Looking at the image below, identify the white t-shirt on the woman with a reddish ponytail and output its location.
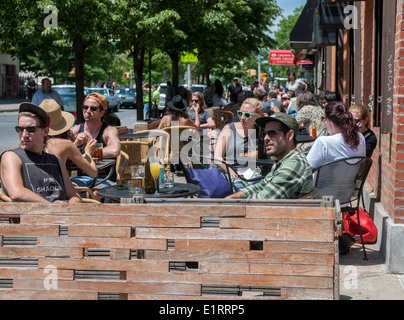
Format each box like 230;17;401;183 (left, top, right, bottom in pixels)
307;133;366;168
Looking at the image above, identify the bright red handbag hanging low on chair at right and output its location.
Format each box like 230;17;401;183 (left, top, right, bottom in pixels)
343;208;377;243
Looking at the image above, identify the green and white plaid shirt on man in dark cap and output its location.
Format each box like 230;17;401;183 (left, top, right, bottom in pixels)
240;149;313;199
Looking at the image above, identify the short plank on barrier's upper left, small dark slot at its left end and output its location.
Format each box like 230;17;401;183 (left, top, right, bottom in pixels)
69;225;131;238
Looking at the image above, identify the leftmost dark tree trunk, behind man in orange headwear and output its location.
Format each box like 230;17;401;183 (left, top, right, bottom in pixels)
73;34;86;123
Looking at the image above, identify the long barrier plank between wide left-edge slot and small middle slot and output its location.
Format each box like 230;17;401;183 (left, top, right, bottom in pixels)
38;237;167;250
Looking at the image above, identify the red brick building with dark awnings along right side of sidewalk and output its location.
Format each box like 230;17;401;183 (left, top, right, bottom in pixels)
290;0;404;273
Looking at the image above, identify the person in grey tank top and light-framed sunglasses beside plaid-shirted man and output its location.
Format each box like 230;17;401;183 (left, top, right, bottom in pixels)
215;98;263;192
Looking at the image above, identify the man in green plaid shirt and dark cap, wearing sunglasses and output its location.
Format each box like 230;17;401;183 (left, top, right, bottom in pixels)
227;112;313;199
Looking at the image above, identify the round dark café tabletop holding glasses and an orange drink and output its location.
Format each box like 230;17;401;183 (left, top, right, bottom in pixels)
98;182;200;201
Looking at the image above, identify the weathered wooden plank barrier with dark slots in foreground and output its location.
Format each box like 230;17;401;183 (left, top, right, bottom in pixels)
0;199;339;300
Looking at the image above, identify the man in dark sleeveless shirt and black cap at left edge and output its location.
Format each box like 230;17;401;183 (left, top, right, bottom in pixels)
1;103;81;203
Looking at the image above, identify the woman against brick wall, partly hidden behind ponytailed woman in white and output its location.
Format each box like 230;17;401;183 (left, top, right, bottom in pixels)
349;104;377;157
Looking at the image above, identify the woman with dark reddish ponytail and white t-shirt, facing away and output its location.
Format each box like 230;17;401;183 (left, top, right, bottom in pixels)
307;101;366;169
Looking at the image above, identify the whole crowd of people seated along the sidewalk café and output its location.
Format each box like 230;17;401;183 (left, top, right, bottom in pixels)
0;71;377;202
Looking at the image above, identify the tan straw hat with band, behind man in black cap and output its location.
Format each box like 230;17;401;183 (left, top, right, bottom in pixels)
39;99;75;136
